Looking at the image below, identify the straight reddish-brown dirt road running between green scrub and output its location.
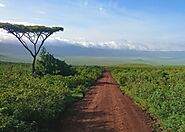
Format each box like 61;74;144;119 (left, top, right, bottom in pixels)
57;72;152;132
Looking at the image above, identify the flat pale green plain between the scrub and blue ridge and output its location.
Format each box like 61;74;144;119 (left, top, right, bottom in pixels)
0;56;185;66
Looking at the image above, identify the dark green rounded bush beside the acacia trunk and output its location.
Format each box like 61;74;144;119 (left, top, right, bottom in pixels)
36;48;74;76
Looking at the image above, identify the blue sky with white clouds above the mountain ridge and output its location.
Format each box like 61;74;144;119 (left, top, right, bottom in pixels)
0;0;185;51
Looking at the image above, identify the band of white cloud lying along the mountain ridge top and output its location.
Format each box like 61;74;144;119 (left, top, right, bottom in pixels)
0;30;185;51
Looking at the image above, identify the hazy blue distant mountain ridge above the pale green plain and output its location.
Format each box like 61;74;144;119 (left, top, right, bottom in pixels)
0;42;185;59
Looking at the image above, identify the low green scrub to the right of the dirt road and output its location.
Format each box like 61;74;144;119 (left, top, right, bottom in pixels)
110;65;185;132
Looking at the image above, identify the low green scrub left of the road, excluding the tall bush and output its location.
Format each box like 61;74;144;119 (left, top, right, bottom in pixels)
0;63;102;132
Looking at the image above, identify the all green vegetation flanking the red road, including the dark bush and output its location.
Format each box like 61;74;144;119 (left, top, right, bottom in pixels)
0;50;185;132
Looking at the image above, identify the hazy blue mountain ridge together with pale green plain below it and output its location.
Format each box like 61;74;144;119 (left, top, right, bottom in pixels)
0;42;185;65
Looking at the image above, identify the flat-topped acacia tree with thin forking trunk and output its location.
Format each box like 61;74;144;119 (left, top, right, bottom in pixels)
0;23;64;75
